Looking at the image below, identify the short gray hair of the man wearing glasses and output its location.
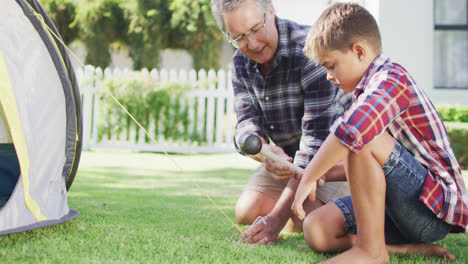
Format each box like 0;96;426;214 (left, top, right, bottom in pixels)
211;0;271;33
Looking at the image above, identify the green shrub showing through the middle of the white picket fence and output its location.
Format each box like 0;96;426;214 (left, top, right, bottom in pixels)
98;77;190;143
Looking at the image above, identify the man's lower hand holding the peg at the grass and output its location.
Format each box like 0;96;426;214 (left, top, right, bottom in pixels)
241;215;282;245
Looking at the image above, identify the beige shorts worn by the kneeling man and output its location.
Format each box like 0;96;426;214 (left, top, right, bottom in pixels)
244;164;350;203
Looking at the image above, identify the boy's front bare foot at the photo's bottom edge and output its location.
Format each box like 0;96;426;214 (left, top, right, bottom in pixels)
322;247;390;264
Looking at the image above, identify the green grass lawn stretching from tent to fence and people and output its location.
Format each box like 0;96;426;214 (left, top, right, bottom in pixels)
0;151;468;263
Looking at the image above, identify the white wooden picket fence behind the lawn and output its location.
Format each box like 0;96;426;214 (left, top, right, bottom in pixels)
76;66;236;153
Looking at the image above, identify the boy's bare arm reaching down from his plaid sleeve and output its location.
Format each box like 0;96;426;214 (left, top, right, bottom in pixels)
291;134;349;220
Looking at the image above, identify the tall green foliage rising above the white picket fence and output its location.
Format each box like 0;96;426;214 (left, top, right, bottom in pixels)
41;0;224;70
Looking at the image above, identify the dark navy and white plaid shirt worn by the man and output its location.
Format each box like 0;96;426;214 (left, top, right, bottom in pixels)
232;17;351;167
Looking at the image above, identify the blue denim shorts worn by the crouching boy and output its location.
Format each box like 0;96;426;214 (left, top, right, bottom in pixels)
332;141;452;244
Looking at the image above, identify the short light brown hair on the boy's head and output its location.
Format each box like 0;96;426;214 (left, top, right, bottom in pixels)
304;3;382;60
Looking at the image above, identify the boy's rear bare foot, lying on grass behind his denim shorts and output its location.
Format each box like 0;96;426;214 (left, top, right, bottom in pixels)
387;244;456;260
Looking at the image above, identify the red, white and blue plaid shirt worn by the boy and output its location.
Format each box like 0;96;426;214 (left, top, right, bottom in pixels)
330;54;468;233
